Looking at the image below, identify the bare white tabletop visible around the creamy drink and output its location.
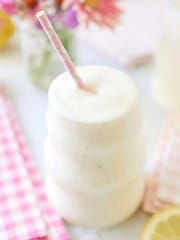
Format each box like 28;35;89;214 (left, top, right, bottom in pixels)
0;38;165;240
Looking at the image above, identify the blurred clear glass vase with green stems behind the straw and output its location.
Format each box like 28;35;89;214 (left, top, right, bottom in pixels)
20;21;74;90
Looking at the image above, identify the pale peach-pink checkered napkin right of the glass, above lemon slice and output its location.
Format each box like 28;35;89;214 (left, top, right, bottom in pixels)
143;118;180;213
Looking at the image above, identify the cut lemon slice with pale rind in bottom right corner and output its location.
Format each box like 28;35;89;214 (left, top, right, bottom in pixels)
141;207;180;240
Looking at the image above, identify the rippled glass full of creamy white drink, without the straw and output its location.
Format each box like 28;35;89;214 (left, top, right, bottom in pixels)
45;66;144;227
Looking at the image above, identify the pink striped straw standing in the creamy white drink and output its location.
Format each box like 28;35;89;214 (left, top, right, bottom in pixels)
36;11;86;90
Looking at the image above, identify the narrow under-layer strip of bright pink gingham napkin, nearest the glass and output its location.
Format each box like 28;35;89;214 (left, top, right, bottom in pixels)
14;115;69;240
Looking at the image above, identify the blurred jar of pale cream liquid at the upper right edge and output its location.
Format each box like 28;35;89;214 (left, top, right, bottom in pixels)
153;0;180;113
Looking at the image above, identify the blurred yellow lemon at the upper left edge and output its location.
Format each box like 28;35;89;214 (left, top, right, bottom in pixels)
0;10;14;48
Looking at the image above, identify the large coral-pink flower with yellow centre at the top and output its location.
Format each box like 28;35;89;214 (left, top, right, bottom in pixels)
65;0;123;29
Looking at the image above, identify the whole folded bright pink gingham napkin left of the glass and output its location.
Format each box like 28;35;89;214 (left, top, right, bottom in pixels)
0;86;69;240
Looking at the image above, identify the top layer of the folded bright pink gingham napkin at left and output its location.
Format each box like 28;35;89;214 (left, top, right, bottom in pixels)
0;92;46;240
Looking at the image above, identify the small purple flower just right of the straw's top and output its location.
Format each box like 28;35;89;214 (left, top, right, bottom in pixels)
61;7;79;28
